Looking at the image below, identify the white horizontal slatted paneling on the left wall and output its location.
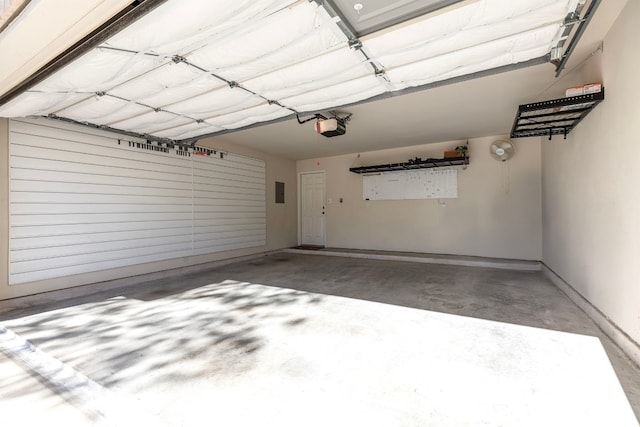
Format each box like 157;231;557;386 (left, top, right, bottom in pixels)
9;120;266;285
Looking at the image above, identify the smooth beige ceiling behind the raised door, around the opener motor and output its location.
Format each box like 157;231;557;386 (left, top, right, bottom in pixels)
208;64;554;160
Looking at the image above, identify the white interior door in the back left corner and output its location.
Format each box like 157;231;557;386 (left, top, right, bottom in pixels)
300;172;325;246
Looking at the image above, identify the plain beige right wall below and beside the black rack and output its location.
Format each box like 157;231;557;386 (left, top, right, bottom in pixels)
543;1;640;343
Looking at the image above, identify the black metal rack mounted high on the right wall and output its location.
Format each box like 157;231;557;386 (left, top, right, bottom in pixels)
511;88;604;139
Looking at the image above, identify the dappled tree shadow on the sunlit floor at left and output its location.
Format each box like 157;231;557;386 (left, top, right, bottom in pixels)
2;276;323;418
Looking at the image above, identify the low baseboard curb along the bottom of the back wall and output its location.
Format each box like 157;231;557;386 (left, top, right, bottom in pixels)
284;248;540;271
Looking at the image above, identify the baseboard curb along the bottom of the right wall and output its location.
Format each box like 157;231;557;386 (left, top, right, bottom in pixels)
542;263;640;366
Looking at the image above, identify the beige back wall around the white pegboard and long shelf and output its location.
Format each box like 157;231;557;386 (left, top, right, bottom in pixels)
298;136;541;260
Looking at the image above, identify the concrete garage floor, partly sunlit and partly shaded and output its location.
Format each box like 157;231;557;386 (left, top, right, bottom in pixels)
0;253;640;426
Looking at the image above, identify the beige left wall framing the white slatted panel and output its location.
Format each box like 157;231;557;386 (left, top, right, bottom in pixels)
0;125;297;300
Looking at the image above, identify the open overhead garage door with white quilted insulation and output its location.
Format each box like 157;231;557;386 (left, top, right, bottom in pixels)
0;0;597;143
